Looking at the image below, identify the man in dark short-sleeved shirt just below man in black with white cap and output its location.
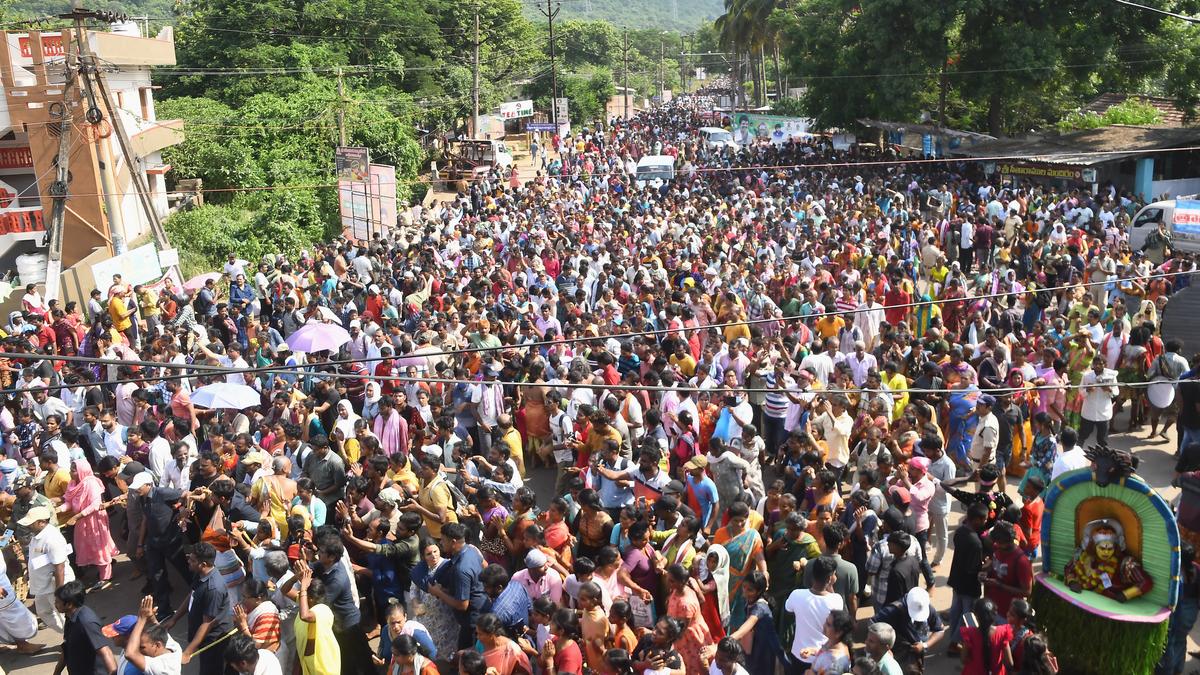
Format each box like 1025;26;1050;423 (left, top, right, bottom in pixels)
163;542;233;675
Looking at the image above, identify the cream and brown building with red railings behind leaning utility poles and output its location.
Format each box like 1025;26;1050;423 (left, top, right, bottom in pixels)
0;23;184;276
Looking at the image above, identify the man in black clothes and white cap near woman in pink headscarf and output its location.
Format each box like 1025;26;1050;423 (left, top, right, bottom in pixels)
130;471;192;621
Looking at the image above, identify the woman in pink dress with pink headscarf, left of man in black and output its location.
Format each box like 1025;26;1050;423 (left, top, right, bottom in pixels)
58;459;118;591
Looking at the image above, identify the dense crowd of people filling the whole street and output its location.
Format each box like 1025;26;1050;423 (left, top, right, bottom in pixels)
0;96;1200;675
